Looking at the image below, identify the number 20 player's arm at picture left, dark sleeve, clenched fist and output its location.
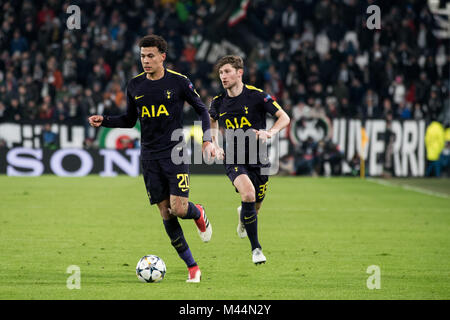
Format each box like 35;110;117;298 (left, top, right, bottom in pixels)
88;90;138;128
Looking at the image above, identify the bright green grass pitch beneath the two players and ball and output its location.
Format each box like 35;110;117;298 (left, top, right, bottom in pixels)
0;175;450;300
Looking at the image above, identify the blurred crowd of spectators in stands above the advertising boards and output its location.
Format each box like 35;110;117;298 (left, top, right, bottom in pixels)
0;0;450;176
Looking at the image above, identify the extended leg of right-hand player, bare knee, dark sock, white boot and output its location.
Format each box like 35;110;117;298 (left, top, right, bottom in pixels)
233;174;266;265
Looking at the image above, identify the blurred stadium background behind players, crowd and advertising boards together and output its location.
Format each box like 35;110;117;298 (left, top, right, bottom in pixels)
0;0;450;177
